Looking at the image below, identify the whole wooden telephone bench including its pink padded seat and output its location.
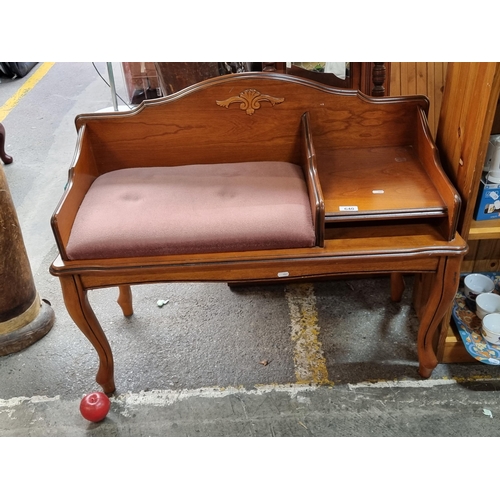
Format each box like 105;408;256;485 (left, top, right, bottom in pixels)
50;72;467;394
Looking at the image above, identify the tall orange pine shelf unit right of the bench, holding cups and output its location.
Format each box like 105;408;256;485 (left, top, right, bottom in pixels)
415;62;500;363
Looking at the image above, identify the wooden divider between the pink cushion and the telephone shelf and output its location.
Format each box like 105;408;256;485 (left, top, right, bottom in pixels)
302;112;325;247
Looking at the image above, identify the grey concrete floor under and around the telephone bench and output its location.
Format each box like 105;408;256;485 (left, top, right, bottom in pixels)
0;63;500;437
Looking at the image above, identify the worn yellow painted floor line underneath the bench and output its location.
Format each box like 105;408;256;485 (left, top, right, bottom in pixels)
285;283;331;385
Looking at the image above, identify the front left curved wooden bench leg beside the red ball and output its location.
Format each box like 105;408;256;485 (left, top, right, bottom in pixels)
59;275;115;395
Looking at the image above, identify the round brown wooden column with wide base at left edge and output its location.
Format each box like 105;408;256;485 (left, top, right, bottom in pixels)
0;164;55;356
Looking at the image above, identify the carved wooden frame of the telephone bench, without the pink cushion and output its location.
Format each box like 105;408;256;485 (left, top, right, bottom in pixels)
50;73;467;394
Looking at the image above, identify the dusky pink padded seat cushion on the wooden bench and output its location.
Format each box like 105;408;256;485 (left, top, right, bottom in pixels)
67;162;315;260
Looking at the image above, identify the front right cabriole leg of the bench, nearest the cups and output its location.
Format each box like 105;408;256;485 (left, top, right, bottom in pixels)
417;256;462;378
